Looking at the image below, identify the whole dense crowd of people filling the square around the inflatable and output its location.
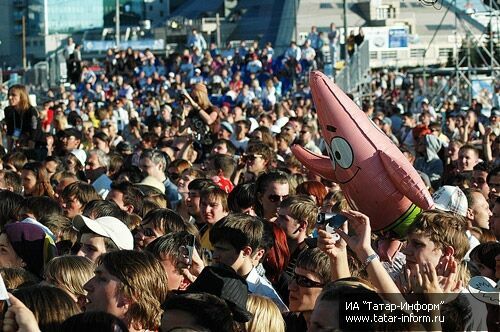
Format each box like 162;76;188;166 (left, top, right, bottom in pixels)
0;25;500;332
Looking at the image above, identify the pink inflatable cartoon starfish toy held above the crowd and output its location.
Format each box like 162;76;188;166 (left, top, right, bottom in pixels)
292;71;434;239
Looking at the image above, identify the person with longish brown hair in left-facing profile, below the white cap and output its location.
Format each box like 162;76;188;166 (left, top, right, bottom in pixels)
84;250;168;331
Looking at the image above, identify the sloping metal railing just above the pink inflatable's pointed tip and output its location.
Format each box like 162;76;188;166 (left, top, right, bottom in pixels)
335;40;370;92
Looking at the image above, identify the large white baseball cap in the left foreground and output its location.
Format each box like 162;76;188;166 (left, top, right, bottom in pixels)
73;215;134;250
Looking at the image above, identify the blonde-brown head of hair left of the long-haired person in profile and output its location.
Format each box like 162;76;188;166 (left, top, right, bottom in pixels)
44;256;95;310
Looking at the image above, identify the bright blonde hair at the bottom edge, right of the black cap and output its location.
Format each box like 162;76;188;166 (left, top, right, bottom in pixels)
245;295;285;332
